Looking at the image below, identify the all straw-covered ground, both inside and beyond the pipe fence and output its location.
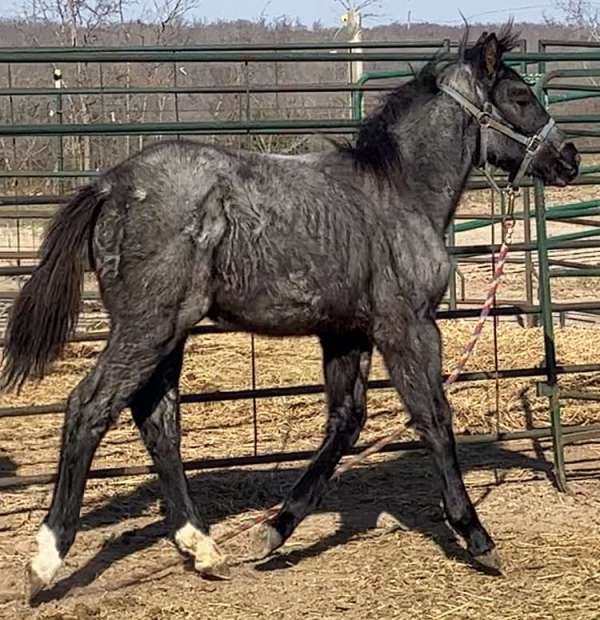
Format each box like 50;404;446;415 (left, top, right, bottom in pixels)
0;323;600;620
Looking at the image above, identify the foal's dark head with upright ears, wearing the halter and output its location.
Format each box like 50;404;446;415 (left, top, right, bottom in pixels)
438;28;580;186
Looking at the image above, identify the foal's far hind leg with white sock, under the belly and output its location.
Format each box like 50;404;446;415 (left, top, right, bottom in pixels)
131;342;229;578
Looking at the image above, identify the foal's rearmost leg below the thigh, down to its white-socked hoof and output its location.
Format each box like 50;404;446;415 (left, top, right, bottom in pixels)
29;325;176;598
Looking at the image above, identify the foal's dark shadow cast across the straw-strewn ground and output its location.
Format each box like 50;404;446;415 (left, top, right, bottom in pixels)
36;444;552;604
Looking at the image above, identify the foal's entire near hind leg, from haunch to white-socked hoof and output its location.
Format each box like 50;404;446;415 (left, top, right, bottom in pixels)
25;180;226;595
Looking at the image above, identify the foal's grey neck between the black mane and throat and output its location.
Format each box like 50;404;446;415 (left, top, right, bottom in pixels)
396;97;477;235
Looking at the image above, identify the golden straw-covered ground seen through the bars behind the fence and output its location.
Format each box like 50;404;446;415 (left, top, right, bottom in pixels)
0;321;600;474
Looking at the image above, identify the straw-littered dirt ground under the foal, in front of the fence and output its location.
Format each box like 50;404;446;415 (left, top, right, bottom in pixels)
0;443;600;620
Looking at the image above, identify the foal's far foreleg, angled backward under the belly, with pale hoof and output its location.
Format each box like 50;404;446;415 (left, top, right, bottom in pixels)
255;333;372;558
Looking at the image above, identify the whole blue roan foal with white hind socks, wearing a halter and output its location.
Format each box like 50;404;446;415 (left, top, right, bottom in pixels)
2;28;579;597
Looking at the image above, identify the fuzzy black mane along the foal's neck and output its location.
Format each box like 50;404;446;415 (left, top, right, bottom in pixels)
339;56;443;178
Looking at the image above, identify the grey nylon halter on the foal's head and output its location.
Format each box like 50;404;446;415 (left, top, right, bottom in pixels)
439;84;556;189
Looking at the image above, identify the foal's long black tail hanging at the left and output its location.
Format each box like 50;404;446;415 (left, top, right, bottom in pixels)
0;184;105;389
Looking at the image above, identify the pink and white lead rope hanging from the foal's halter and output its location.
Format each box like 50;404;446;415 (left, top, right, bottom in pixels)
216;213;515;543
